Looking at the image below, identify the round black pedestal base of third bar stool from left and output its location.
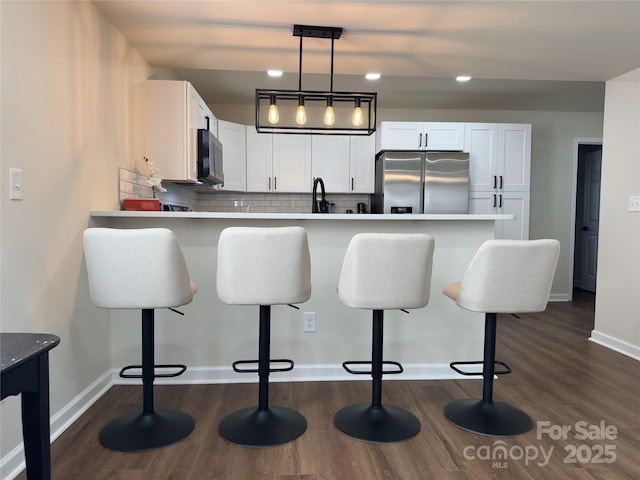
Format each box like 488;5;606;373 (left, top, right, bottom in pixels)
333;403;420;443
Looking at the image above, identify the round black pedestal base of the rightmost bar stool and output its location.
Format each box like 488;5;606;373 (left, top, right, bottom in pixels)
444;398;533;437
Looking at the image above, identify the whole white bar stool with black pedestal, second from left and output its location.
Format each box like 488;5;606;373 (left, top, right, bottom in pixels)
216;227;311;447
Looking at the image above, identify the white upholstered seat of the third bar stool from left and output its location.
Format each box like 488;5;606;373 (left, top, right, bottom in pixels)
338;233;434;310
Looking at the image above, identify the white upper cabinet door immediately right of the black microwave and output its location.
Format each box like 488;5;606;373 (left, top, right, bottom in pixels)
218;120;247;192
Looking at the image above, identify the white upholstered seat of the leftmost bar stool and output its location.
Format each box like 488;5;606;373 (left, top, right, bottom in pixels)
84;228;198;309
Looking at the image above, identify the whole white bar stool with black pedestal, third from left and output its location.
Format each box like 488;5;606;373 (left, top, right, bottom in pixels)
334;233;434;442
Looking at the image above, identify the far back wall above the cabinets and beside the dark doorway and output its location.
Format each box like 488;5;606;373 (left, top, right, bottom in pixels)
215;105;603;299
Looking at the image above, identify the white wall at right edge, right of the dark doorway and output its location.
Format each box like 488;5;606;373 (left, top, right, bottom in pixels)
591;69;640;359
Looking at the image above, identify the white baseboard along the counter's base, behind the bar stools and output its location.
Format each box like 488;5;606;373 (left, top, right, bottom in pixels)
112;363;469;385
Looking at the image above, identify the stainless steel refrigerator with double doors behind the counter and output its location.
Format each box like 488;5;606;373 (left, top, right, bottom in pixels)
371;151;469;214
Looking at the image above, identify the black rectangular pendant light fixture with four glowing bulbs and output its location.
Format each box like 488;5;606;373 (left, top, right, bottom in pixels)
256;25;377;135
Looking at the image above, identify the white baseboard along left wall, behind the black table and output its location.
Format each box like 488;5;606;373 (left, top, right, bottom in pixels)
0;370;113;480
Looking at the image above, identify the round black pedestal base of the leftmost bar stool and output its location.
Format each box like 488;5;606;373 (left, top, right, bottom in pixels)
99;410;195;452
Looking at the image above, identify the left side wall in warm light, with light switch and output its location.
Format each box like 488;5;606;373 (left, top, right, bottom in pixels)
0;2;148;478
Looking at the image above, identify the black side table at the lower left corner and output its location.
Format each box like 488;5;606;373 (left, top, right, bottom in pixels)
0;333;60;480
